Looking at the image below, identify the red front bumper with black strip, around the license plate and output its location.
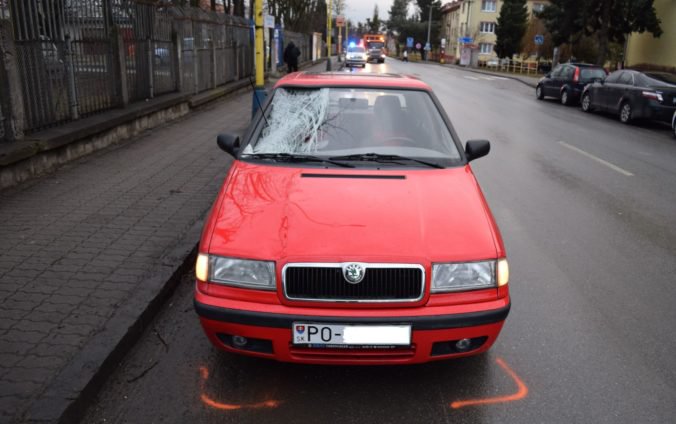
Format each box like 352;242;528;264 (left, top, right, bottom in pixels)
195;296;510;365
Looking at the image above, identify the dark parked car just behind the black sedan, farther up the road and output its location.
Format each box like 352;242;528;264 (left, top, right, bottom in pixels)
535;63;606;106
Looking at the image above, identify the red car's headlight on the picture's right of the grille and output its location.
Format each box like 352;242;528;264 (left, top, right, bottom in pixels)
431;259;509;293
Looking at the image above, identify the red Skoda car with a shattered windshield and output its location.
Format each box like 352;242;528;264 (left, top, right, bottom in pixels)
195;73;510;364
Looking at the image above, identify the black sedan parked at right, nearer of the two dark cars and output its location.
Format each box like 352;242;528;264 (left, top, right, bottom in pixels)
581;69;676;124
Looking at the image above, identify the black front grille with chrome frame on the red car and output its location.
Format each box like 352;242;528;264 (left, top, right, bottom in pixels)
284;264;425;302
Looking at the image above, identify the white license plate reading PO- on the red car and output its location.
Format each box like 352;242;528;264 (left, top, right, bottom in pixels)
291;322;411;347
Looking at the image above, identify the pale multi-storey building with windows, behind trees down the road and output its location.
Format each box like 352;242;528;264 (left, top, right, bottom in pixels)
441;0;548;62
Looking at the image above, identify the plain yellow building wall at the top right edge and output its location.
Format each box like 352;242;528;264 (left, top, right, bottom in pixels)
625;0;676;72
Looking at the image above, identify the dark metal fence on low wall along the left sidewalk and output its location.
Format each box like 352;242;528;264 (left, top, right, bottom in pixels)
0;0;253;135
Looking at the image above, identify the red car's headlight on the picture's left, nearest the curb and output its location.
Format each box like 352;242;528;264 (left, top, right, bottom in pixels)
195;253;276;290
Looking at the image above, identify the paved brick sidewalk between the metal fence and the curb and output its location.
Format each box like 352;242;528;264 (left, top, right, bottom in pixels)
0;57;336;423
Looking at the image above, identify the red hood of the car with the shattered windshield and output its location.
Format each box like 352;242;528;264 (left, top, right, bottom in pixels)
207;161;504;263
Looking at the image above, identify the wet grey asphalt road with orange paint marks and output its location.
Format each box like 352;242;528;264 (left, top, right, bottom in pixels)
83;61;676;423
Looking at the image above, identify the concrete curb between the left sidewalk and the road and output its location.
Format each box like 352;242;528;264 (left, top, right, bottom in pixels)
22;220;206;423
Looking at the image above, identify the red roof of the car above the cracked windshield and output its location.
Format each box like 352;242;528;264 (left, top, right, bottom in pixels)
275;72;432;91
